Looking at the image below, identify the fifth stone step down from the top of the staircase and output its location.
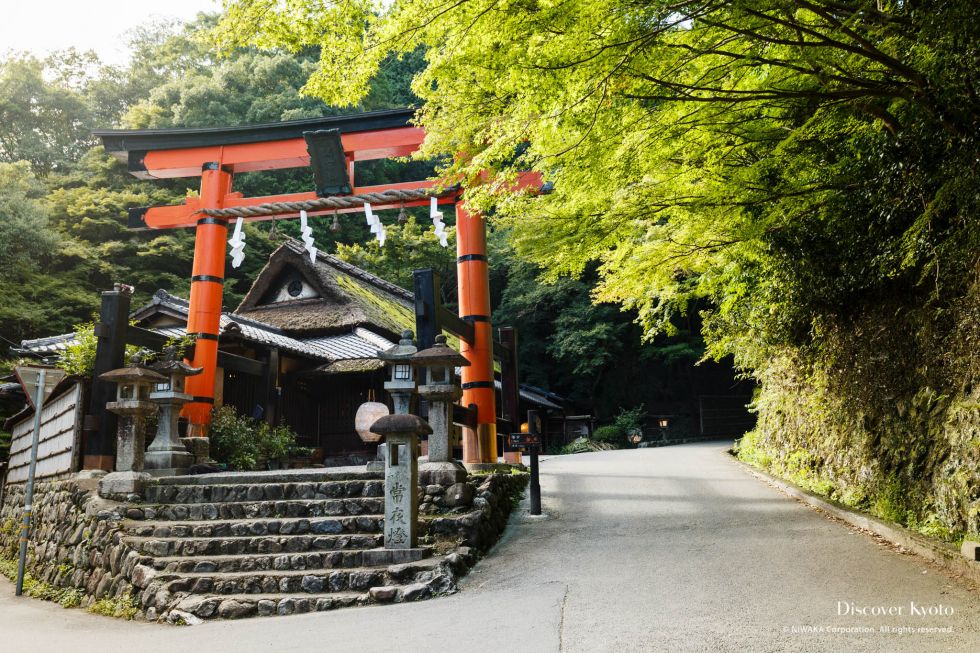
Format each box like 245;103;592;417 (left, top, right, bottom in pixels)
125;533;384;557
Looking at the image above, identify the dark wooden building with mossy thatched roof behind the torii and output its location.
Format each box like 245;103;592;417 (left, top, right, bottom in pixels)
22;240;415;465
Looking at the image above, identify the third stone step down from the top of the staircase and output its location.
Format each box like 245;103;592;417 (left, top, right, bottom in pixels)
126;497;384;521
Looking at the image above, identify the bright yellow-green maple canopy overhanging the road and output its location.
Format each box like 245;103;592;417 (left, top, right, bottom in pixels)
220;0;980;364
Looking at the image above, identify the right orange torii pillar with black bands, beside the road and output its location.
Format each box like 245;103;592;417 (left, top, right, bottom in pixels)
456;202;497;464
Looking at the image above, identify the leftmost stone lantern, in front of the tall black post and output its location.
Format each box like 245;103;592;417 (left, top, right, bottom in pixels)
99;357;166;496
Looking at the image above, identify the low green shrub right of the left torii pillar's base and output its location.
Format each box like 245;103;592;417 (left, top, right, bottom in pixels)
210;406;296;470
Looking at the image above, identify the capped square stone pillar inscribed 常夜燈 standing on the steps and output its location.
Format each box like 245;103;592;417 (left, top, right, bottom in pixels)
371;415;432;549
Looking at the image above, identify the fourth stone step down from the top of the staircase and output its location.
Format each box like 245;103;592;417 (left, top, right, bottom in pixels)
123;515;384;537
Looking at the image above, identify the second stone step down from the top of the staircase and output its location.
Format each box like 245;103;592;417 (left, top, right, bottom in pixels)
146;479;384;504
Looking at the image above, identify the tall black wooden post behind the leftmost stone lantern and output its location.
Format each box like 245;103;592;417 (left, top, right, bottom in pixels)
82;283;133;471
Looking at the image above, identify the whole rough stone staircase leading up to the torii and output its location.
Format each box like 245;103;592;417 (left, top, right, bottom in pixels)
121;468;455;621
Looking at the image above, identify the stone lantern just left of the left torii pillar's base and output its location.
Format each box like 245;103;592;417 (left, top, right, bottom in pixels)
146;348;203;476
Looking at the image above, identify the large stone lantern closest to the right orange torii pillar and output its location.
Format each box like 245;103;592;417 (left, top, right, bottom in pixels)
412;334;470;485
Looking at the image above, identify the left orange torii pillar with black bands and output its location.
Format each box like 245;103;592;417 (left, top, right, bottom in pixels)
182;161;232;436
